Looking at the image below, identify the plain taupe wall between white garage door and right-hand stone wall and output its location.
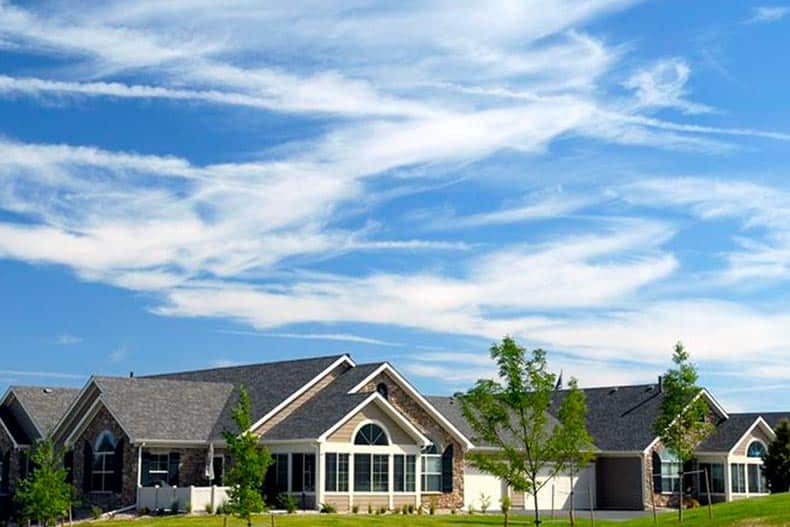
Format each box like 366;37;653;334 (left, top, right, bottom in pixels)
595;456;644;510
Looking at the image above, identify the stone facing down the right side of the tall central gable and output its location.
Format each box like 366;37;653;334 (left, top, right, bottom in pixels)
360;373;465;509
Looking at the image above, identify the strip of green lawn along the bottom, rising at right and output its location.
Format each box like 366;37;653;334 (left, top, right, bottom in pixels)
106;494;790;527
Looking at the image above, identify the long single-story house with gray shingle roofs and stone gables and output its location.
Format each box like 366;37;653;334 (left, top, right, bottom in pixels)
0;355;790;514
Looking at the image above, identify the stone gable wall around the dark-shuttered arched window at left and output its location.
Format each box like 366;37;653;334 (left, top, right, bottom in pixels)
73;406;137;509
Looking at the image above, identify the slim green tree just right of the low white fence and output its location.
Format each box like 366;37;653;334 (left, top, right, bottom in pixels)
224;386;272;527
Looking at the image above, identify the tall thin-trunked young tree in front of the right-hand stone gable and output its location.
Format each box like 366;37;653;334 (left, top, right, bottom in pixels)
655;342;713;521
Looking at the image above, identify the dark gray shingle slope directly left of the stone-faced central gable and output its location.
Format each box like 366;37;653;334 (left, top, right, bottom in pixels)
263;363;384;440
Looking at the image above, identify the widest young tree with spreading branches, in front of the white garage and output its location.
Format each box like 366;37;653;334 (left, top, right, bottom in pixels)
458;337;584;525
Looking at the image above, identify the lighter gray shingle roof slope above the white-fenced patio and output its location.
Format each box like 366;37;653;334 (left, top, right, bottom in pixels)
94;377;236;441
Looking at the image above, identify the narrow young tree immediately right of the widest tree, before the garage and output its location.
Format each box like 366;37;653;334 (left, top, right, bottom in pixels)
557;378;595;527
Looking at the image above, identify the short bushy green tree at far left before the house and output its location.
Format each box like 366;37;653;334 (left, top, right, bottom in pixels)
16;438;73;527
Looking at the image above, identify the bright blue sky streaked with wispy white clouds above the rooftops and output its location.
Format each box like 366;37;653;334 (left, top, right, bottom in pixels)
0;0;790;410
